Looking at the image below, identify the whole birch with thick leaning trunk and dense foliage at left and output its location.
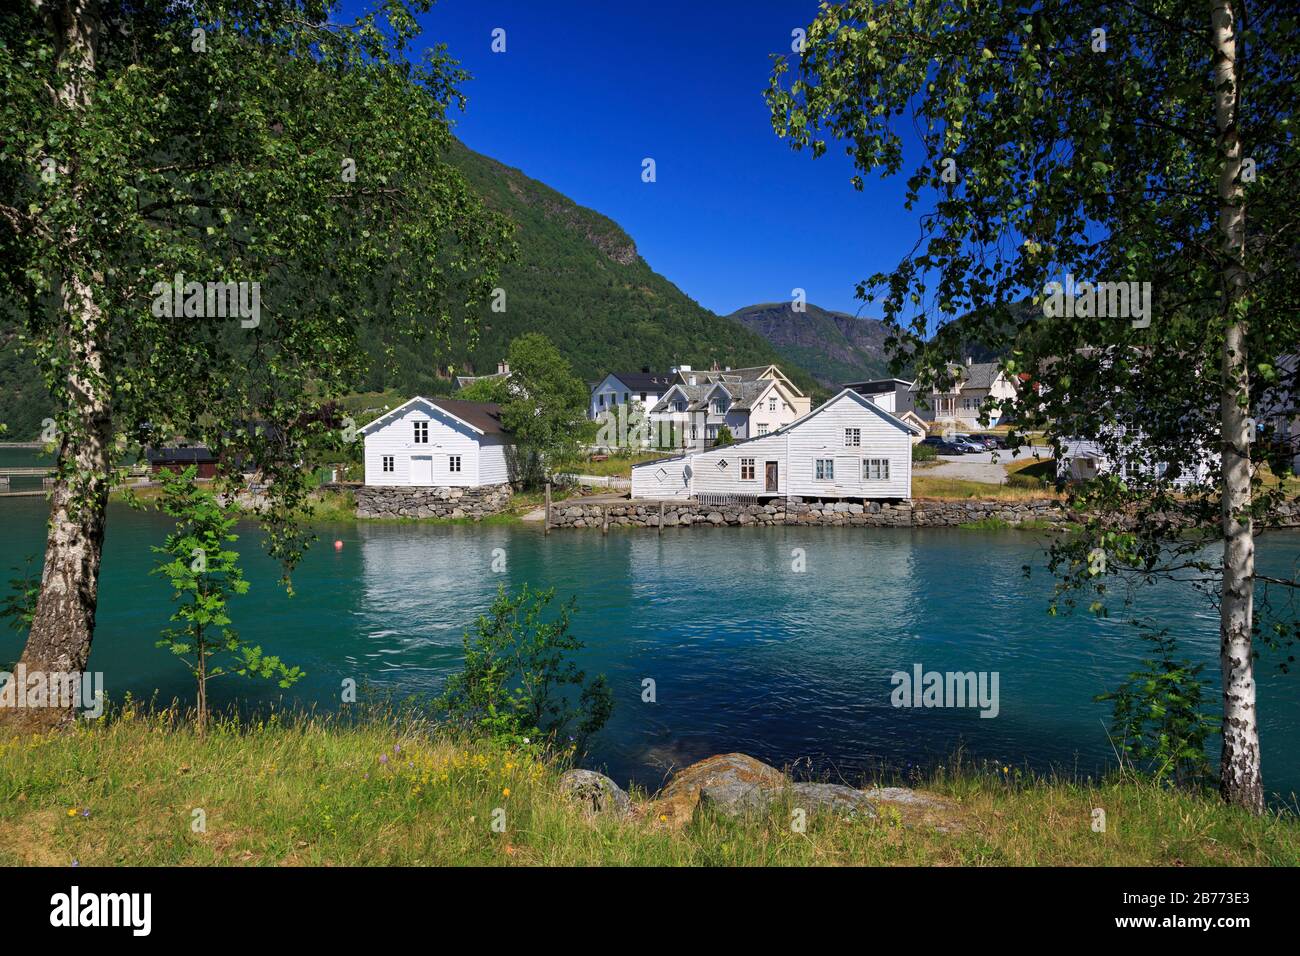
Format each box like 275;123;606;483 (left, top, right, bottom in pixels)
0;0;508;722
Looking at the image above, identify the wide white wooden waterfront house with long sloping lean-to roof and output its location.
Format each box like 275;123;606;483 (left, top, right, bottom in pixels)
632;389;917;499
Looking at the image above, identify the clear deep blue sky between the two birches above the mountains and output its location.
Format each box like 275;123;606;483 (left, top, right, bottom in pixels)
358;0;918;315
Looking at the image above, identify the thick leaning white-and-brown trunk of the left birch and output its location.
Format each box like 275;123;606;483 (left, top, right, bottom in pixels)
4;0;112;727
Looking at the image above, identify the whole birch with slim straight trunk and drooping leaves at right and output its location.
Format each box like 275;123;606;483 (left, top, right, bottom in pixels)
767;0;1300;812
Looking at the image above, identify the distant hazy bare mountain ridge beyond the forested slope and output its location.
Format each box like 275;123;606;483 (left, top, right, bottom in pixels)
727;302;889;392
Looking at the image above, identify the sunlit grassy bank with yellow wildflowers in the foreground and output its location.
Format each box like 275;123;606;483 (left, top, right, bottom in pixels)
0;705;1300;866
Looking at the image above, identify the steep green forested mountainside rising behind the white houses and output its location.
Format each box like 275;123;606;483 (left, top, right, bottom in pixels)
0;143;815;440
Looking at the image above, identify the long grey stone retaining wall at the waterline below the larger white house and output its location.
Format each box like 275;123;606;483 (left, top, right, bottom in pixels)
551;498;1300;528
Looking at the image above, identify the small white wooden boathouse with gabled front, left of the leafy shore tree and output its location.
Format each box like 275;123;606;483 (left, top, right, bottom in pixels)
361;397;511;488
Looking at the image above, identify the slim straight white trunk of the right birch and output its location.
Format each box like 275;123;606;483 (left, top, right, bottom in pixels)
1210;0;1264;813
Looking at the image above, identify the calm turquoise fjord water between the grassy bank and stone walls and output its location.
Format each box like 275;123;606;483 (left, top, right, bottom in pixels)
0;498;1300;795
